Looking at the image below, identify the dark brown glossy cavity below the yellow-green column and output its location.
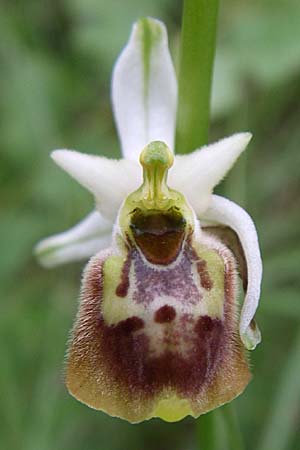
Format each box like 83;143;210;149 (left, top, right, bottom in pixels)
130;208;186;265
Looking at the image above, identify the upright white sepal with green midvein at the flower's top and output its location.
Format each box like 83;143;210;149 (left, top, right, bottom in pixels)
112;18;177;161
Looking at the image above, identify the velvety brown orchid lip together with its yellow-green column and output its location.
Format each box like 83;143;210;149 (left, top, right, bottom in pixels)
66;141;250;422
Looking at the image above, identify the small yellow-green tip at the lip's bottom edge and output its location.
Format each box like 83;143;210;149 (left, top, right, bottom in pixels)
153;394;193;422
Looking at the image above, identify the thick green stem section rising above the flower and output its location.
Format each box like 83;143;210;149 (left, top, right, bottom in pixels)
176;0;219;153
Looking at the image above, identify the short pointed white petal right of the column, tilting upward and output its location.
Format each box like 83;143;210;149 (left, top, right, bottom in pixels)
169;133;252;216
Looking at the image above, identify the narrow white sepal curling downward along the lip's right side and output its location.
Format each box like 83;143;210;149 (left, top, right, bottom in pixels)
200;195;262;350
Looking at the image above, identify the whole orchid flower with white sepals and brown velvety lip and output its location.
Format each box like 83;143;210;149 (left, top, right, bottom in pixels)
36;19;262;422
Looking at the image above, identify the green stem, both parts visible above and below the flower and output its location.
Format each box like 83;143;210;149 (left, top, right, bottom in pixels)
176;0;244;450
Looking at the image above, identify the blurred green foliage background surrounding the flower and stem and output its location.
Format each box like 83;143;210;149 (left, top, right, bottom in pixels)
0;0;300;450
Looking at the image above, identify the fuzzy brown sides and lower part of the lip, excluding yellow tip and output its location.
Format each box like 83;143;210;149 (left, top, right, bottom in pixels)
66;237;250;422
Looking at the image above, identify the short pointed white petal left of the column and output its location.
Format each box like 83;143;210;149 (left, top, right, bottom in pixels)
51;150;141;222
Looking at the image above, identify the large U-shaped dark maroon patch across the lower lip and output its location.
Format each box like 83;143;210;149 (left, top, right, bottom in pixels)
101;316;224;395
